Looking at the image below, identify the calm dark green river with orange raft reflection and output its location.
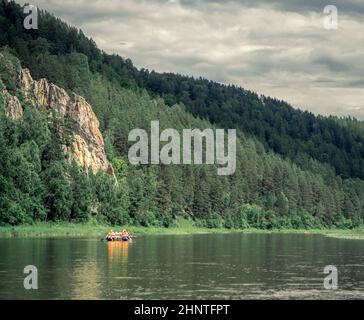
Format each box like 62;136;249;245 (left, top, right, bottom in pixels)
0;233;364;299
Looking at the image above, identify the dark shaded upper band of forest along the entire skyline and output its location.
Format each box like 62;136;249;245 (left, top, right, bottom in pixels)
0;0;364;179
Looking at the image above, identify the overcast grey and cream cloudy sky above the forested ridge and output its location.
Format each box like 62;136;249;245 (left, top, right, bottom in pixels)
18;0;364;119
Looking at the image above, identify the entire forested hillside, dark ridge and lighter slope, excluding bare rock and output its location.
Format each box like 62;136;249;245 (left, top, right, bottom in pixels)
0;0;364;228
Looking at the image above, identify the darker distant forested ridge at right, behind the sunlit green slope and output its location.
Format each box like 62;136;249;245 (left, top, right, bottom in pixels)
136;70;364;179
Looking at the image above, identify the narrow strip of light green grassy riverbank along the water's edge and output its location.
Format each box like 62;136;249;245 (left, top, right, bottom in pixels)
0;221;364;240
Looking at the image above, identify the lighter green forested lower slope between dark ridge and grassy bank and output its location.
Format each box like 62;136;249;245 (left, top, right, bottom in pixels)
0;51;364;228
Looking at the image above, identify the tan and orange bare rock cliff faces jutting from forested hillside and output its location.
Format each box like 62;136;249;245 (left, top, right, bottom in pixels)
3;69;115;177
